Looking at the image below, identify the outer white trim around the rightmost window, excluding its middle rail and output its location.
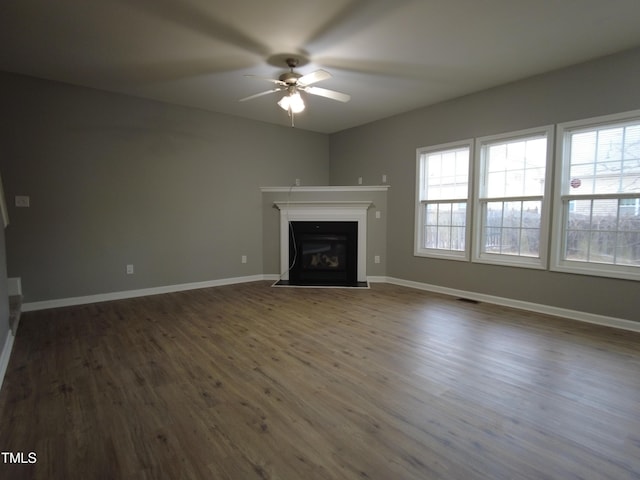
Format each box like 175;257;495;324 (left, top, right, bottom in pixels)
549;110;640;280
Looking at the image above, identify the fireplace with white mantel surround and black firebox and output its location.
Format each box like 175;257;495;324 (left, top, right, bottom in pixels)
275;201;371;287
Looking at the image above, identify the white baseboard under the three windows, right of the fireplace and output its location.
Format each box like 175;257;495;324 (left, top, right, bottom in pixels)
385;277;640;332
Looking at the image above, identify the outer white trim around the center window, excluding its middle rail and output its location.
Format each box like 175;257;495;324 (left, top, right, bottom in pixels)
471;125;554;270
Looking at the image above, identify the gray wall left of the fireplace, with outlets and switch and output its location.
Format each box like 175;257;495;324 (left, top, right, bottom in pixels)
0;73;329;302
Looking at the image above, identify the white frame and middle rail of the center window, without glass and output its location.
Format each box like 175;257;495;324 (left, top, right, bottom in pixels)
471;125;555;270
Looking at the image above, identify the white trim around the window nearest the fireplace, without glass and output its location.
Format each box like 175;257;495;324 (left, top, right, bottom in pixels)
413;138;474;261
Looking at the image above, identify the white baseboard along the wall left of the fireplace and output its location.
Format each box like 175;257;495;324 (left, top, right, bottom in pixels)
22;275;268;312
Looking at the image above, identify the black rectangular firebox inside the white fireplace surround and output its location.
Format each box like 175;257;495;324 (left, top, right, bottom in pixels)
289;222;358;286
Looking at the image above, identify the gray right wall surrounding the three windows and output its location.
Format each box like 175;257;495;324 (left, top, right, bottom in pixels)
330;49;640;320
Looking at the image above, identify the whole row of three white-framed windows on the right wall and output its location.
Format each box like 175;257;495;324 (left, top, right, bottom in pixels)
414;110;640;280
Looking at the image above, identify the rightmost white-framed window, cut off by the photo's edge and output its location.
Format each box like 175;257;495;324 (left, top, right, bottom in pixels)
551;111;640;279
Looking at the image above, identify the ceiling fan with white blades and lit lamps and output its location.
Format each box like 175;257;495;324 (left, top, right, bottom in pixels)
240;57;351;126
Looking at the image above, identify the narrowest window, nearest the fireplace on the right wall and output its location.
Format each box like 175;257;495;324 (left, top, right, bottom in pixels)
415;140;473;260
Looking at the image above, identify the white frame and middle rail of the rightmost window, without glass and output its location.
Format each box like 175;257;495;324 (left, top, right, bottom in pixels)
549;110;640;281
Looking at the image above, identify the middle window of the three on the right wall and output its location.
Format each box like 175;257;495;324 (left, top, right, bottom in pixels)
473;126;553;268
